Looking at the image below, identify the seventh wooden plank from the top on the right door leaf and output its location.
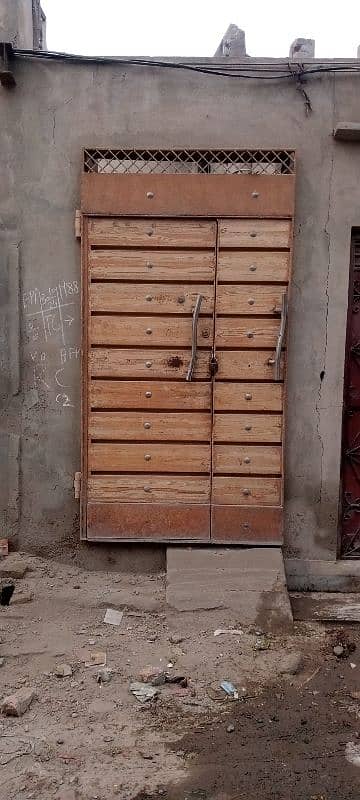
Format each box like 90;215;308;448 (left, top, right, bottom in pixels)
213;413;282;443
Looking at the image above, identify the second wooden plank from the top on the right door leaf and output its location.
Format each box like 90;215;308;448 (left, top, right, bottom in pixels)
218;255;290;283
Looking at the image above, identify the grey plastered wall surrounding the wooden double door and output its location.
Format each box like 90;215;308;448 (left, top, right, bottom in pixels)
0;50;360;559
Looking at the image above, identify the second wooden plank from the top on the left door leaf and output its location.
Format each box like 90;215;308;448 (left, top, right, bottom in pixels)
89;249;215;283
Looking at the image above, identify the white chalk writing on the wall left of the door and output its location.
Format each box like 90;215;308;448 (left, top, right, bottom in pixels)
22;280;81;408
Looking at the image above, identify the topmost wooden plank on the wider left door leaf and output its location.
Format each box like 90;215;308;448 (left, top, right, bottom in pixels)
88;217;216;249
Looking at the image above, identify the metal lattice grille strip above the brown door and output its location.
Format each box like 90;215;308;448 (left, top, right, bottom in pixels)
84;149;295;175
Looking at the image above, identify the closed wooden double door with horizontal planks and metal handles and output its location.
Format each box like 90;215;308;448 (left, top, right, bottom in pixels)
82;216;292;544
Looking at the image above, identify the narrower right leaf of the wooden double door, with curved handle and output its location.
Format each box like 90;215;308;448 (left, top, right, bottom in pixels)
211;218;292;545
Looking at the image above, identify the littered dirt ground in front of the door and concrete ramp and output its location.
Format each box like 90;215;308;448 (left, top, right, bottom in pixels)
0;557;360;800
